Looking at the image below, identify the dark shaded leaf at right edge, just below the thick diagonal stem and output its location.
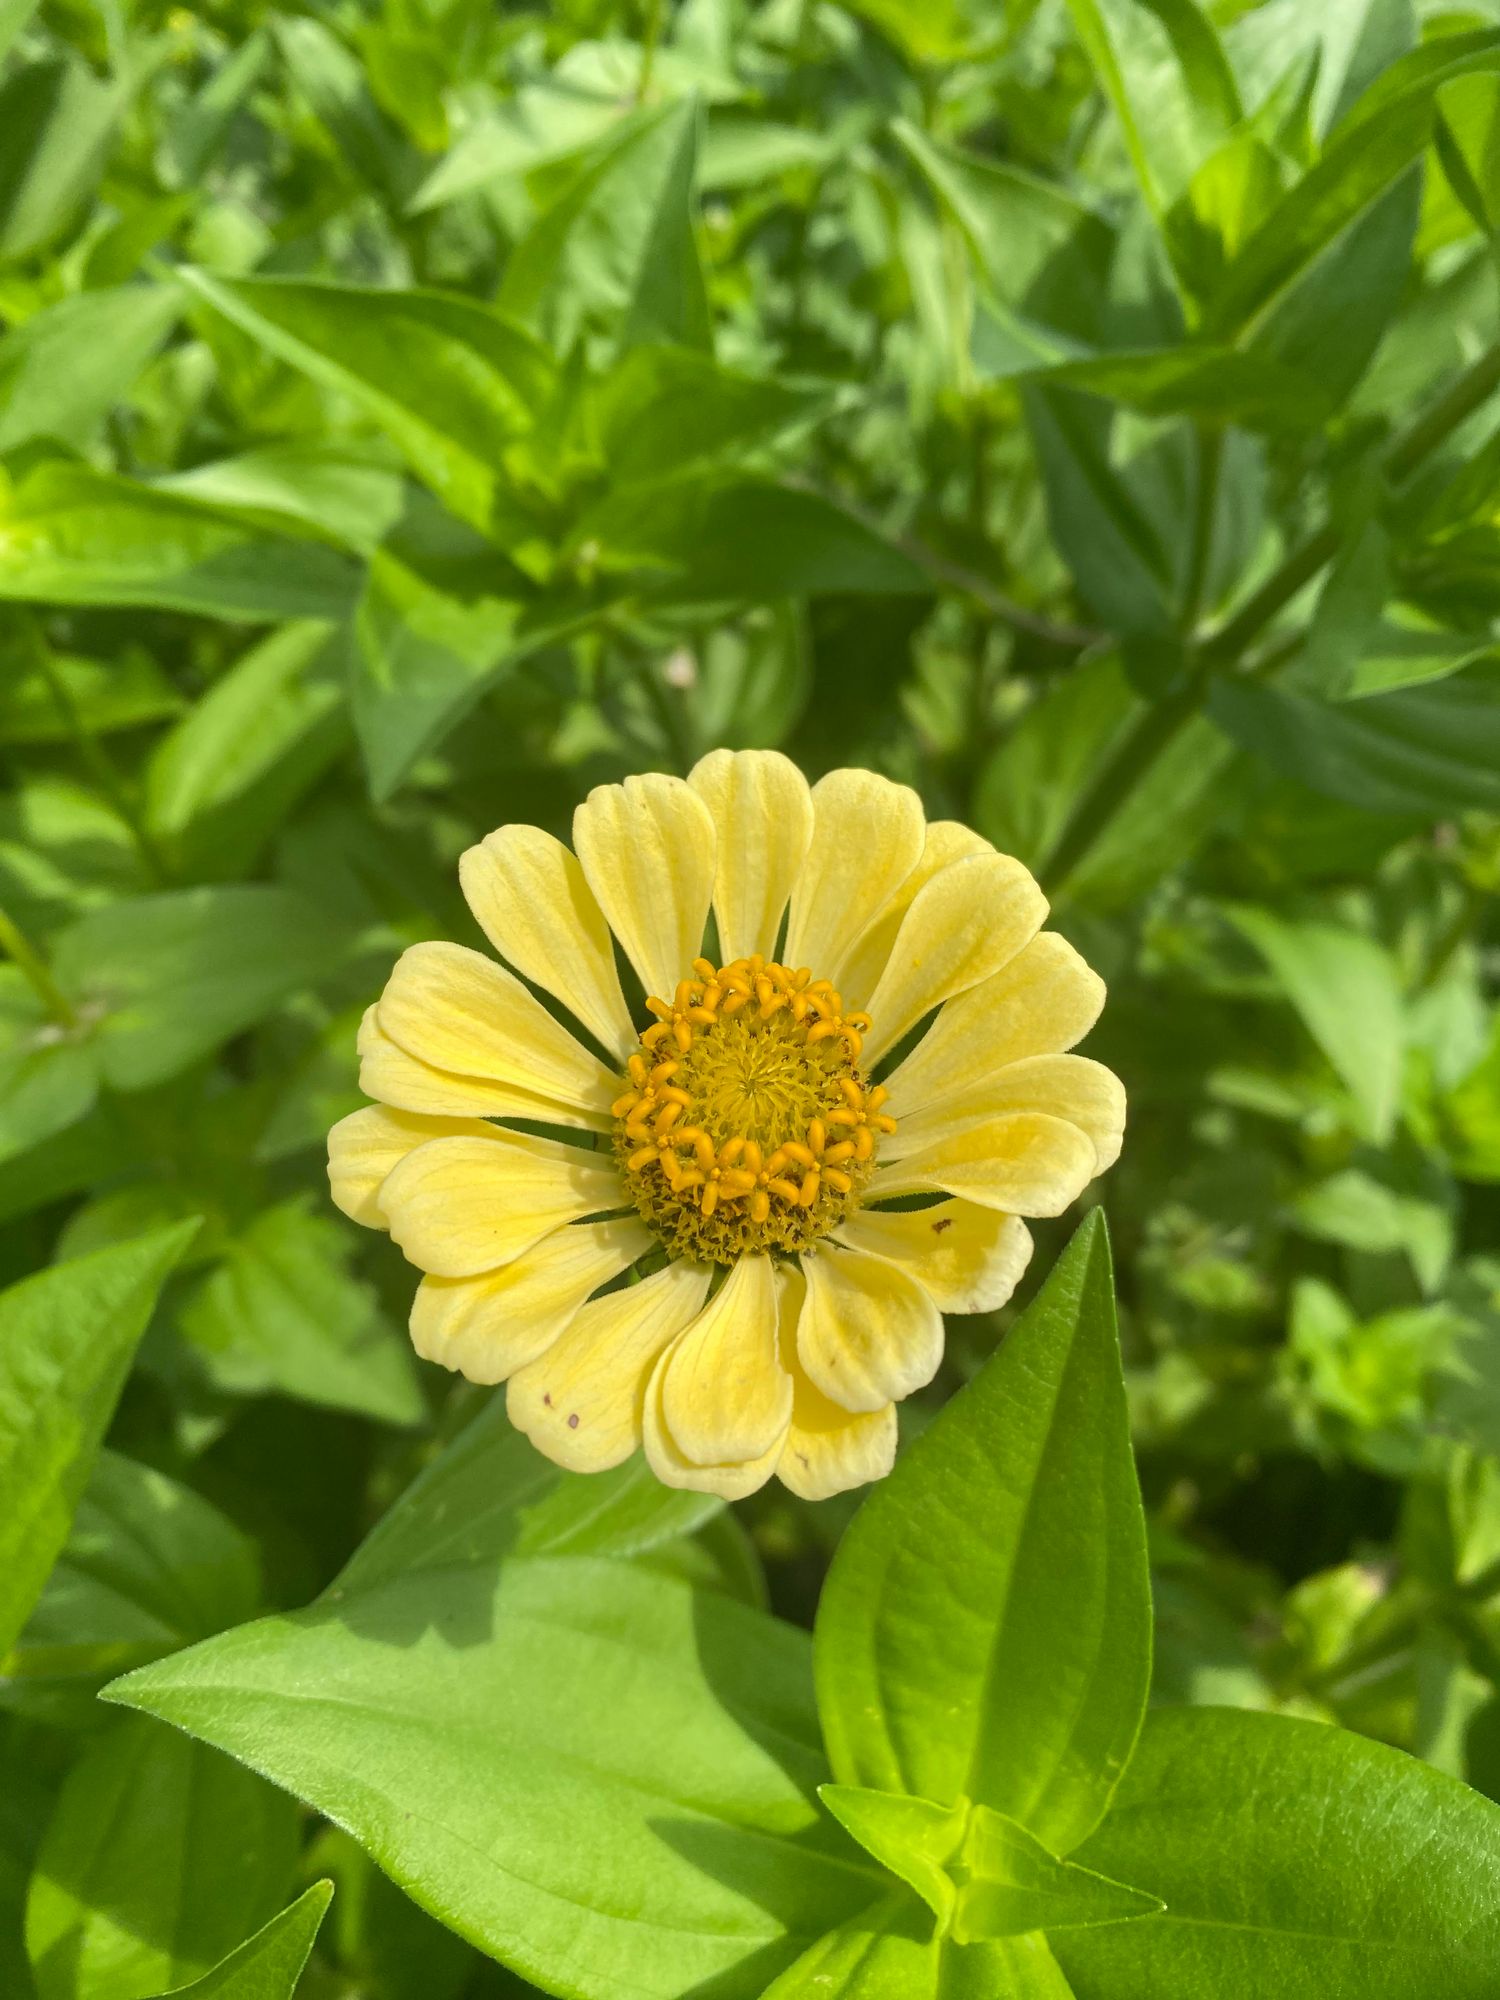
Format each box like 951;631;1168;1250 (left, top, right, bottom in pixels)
1208;660;1500;820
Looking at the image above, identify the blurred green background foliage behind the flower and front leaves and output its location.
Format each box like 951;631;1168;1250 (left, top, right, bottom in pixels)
0;0;1500;2000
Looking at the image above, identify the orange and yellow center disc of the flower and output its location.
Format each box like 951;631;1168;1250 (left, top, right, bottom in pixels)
612;954;896;1264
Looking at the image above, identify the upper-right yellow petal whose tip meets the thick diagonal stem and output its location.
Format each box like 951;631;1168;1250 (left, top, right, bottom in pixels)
864;854;1046;1064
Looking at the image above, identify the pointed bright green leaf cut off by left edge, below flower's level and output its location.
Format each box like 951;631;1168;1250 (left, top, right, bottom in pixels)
0;1222;198;1652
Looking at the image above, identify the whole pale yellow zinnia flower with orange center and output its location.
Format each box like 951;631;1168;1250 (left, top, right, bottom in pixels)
328;750;1124;1498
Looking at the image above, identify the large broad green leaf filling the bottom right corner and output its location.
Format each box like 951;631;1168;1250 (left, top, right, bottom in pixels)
1054;1708;1500;2000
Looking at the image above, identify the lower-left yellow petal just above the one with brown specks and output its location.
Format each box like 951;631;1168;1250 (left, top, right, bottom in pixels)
412;1216;654;1382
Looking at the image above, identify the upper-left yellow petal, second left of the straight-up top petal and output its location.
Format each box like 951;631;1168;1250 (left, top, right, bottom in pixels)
458;824;636;1062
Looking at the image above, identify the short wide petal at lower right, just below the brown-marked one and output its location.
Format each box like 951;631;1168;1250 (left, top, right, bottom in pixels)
796;1242;942;1412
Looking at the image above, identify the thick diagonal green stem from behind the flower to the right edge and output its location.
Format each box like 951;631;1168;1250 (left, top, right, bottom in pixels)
1046;344;1500;896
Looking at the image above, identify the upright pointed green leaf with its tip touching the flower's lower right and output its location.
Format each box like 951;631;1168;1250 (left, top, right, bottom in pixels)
816;1214;1150;1854
